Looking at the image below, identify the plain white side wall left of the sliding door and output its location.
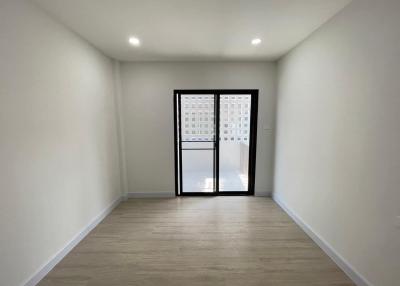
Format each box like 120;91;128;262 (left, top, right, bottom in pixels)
0;0;121;286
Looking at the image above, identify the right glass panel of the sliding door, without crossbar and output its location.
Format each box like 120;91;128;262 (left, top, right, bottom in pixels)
219;94;251;192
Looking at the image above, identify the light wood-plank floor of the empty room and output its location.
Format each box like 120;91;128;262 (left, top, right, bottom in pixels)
39;197;354;286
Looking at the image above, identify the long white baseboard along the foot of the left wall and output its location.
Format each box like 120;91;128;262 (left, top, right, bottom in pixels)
22;197;122;286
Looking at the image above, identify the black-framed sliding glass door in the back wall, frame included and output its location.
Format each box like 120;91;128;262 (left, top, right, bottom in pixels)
174;90;258;195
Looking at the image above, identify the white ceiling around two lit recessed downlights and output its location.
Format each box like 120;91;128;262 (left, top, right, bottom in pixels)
32;0;351;61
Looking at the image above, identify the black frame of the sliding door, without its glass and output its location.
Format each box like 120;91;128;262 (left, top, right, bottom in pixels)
173;89;258;196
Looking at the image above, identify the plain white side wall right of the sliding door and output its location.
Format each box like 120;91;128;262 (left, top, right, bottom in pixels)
274;0;400;286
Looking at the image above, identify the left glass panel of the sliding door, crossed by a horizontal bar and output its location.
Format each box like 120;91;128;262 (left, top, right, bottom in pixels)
181;94;215;193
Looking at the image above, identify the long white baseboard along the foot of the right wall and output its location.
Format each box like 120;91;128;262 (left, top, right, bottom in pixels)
272;195;373;286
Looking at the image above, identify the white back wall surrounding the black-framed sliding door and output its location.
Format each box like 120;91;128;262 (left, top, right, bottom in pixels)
121;62;276;197
